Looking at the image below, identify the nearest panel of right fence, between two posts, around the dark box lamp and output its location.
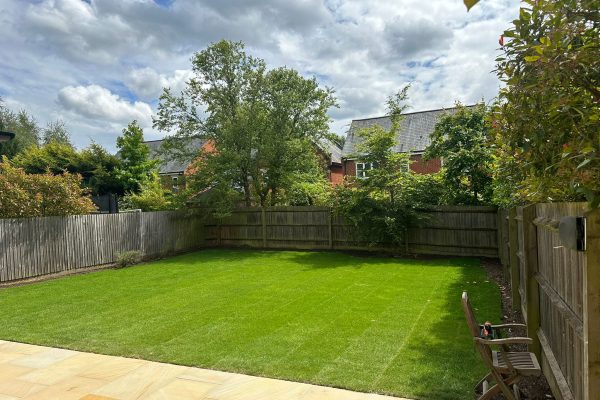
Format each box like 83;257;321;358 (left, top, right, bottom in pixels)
534;203;586;399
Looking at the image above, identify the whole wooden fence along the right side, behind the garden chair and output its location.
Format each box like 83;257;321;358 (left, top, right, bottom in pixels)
498;203;600;400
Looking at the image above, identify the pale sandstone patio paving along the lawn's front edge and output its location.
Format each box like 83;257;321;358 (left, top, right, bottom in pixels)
0;340;408;400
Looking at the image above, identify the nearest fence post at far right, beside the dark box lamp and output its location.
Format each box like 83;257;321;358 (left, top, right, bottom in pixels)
583;209;600;400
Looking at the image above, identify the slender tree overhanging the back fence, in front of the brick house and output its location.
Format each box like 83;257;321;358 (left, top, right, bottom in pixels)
335;87;426;246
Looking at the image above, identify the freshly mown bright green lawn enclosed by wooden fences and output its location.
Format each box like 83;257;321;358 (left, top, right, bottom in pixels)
0;250;500;399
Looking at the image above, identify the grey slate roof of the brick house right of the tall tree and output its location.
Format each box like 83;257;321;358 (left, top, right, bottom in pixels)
342;106;470;158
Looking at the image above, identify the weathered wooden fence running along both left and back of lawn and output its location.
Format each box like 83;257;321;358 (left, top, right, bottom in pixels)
0;207;498;282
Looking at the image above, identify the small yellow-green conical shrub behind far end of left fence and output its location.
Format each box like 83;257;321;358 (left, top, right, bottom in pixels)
121;172;174;211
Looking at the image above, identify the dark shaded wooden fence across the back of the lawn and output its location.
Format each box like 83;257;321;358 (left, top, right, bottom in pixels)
206;206;498;257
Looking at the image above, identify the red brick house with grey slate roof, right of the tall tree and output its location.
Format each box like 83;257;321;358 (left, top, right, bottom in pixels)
342;107;464;178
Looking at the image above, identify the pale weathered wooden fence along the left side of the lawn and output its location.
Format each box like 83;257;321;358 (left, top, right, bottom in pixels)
0;211;204;282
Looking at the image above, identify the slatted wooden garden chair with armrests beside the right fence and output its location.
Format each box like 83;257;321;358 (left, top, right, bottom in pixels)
462;292;541;400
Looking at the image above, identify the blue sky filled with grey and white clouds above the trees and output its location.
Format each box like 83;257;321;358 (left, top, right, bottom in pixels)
0;0;519;151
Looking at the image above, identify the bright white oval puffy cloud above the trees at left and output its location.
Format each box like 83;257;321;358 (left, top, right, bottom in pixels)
58;85;152;127
